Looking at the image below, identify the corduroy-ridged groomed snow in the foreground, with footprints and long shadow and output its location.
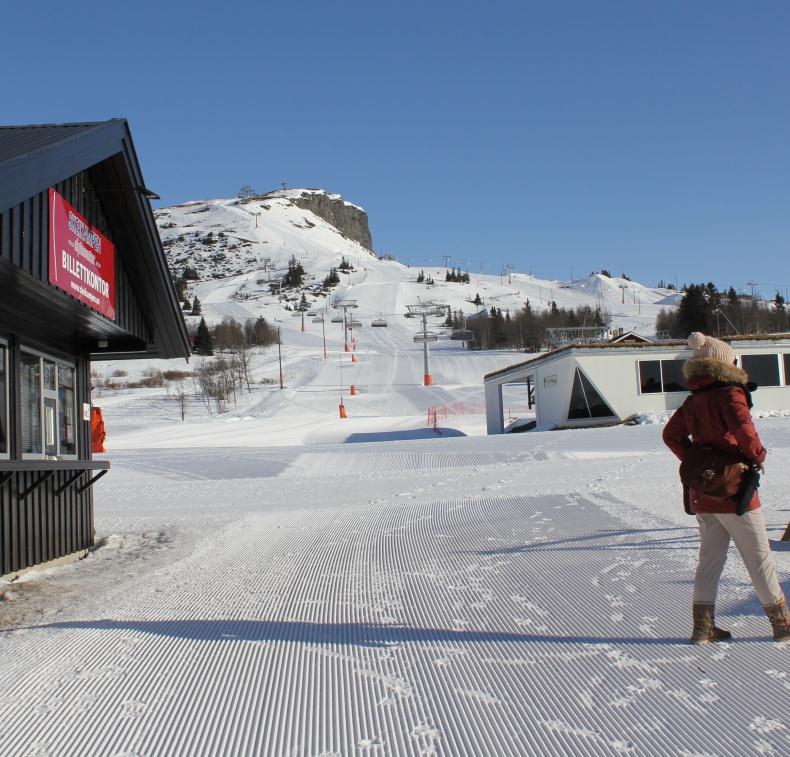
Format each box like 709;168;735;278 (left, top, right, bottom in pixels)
0;482;790;757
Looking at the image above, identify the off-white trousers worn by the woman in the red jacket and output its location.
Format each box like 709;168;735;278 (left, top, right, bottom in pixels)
694;508;784;605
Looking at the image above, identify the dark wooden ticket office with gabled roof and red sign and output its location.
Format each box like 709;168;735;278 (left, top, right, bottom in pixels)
0;119;189;575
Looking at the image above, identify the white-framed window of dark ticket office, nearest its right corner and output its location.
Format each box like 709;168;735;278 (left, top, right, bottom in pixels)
19;352;77;457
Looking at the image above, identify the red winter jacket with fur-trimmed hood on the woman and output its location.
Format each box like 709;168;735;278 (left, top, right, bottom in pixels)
663;358;766;513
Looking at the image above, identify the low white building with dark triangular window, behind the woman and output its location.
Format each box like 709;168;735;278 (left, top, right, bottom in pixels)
484;335;790;434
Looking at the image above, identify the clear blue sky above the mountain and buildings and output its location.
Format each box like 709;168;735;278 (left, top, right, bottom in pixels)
6;0;790;296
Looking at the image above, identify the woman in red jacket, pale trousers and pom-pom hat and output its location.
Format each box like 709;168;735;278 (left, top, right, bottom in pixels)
663;332;790;644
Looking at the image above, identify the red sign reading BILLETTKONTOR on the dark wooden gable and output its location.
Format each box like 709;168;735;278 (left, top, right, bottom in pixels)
49;189;115;320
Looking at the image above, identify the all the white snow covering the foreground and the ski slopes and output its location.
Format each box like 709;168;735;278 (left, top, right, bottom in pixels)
0;193;790;757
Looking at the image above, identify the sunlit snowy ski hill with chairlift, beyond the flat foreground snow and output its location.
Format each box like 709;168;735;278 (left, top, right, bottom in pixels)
96;190;673;450
